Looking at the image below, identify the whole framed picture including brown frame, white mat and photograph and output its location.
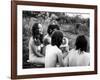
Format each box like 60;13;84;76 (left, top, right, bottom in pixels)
11;1;97;79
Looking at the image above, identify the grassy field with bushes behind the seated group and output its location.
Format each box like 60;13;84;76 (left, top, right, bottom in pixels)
22;11;90;68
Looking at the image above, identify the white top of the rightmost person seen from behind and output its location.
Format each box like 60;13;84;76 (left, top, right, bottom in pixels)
64;49;90;66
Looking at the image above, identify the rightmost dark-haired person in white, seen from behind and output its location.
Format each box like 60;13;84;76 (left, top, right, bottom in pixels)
64;35;90;66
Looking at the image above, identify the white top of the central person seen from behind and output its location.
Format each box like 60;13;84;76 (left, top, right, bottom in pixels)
45;44;63;67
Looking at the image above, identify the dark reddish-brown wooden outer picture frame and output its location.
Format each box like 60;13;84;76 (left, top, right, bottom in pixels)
11;1;97;79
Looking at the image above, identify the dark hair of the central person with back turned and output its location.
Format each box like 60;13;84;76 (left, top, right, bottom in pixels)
51;30;63;47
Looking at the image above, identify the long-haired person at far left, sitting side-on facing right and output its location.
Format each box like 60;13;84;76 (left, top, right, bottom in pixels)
28;23;45;64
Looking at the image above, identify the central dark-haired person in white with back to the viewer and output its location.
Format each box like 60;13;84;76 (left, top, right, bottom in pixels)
45;30;64;68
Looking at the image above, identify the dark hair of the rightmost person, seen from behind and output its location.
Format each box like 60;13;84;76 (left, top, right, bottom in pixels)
75;35;87;51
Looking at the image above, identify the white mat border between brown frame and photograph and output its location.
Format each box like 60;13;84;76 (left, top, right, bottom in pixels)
17;5;95;75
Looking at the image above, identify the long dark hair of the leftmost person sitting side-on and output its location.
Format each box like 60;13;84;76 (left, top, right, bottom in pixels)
32;23;43;43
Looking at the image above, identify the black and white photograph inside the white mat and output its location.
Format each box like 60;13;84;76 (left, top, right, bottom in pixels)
22;11;90;69
